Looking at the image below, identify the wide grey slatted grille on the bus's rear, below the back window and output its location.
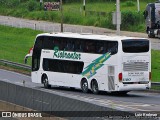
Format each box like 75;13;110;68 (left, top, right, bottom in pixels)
123;62;149;71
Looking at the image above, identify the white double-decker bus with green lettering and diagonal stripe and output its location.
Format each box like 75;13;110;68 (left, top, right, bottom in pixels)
25;33;151;94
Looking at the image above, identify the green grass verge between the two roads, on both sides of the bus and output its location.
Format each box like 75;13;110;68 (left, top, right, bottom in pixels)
0;25;160;82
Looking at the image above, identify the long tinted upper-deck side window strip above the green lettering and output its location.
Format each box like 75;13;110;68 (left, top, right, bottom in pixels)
34;36;118;55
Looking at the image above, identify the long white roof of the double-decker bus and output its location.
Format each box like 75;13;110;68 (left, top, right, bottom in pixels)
37;32;147;41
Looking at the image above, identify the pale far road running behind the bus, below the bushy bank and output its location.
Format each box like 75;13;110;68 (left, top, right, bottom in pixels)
0;16;160;50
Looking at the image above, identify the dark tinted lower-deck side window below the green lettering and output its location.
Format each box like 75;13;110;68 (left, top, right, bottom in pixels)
43;58;84;74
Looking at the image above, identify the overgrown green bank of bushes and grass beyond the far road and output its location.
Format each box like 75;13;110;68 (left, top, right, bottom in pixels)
0;0;155;32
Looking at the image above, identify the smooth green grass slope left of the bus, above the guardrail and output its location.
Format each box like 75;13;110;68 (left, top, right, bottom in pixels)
0;25;41;63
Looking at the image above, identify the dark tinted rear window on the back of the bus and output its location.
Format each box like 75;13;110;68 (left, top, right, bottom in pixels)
122;39;149;53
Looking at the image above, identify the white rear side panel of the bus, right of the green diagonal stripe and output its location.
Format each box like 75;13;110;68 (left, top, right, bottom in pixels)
92;55;118;91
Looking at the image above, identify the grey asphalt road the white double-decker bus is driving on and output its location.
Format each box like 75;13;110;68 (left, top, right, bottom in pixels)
0;69;160;113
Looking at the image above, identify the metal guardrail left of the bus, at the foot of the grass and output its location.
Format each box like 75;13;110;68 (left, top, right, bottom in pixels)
0;59;31;70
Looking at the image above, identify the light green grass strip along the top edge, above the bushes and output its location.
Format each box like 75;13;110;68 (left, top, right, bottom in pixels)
64;0;155;12
